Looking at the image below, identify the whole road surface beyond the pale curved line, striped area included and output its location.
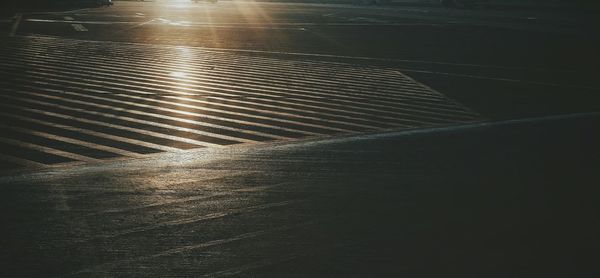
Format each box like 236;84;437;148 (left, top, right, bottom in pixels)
0;1;600;168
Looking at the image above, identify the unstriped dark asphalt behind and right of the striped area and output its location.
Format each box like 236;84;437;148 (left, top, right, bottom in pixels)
5;1;600;118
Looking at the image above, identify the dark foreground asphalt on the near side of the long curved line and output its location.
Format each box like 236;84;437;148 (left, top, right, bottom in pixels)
0;114;600;277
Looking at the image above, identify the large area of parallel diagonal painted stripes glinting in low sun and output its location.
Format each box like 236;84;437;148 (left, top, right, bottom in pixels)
0;37;480;168
